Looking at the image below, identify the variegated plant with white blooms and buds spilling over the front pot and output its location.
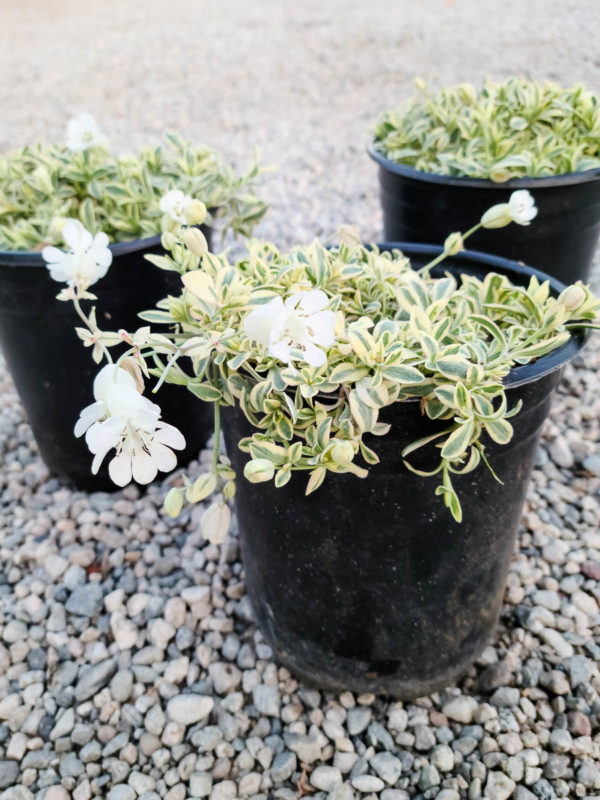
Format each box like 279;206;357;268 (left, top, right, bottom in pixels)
63;192;600;541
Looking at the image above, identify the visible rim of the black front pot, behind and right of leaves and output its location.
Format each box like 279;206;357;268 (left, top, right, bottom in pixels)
377;242;589;392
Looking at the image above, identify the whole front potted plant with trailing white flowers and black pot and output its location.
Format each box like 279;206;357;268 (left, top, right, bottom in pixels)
62;196;599;697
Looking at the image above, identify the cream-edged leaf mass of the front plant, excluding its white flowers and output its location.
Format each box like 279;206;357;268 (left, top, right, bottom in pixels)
137;240;600;519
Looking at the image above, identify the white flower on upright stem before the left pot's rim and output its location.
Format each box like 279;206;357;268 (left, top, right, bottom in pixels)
42;219;112;288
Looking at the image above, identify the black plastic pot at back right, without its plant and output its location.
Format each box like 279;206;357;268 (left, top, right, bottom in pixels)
369;147;600;284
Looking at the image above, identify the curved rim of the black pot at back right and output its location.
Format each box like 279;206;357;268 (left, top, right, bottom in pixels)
367;142;600;189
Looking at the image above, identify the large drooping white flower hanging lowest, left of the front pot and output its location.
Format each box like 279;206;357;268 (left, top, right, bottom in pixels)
74;364;185;486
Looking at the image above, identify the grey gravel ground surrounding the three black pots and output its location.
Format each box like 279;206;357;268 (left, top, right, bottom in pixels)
0;0;600;800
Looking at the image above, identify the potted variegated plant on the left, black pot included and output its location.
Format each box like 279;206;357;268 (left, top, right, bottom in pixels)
0;114;266;489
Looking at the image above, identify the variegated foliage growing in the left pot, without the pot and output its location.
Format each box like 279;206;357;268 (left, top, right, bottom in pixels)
0;115;267;251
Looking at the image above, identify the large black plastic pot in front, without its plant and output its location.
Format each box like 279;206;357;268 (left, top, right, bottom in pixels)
224;244;585;699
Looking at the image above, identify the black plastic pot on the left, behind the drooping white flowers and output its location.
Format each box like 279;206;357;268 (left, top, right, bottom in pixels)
0;228;212;491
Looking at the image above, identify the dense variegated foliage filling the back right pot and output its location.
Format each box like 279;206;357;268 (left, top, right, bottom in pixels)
374;78;600;182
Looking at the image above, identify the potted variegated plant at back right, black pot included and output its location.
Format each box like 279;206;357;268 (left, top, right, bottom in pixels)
369;78;600;283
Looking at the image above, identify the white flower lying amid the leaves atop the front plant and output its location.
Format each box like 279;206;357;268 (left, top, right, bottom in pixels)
244;289;335;367
